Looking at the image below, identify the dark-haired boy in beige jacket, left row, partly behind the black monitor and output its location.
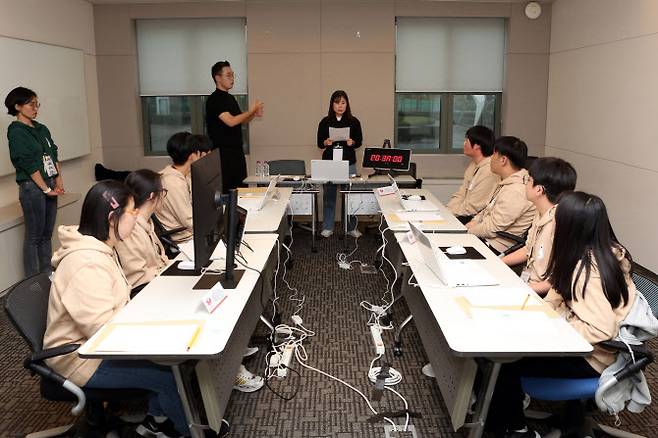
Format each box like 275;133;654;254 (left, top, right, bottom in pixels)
155;132;201;243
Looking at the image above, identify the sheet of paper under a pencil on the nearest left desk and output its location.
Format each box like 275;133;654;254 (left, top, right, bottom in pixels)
94;321;201;354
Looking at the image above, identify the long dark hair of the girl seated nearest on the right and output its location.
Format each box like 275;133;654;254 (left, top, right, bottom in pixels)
547;192;632;309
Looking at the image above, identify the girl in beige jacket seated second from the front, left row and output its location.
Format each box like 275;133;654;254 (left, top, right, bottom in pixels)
116;169;169;289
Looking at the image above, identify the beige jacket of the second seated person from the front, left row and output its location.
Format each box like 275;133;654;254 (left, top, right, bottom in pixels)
116;215;169;287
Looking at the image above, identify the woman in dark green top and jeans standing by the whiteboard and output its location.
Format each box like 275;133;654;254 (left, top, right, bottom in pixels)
5;87;64;277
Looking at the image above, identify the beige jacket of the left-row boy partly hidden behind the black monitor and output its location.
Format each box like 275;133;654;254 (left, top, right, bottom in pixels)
155;165;192;242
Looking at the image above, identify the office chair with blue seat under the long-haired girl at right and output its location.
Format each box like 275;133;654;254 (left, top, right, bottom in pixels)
522;263;658;438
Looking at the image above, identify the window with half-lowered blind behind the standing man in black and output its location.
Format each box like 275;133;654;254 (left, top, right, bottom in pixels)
136;18;249;155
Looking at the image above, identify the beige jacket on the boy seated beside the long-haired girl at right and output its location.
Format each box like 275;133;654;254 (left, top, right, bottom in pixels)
524;205;557;282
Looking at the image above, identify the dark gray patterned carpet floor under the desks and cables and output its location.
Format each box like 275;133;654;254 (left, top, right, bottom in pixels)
0;229;658;438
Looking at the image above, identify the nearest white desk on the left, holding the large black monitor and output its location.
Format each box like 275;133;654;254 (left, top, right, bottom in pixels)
78;234;277;437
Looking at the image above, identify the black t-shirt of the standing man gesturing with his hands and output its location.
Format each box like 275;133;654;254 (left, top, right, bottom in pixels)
206;89;242;149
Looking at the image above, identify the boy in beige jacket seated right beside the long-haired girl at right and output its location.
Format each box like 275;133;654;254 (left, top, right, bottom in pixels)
502;157;577;296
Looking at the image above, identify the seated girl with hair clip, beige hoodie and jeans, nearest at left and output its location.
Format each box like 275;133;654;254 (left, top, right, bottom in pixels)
43;180;189;436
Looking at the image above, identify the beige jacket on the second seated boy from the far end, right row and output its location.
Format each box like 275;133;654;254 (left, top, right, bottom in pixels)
468;169;536;252
